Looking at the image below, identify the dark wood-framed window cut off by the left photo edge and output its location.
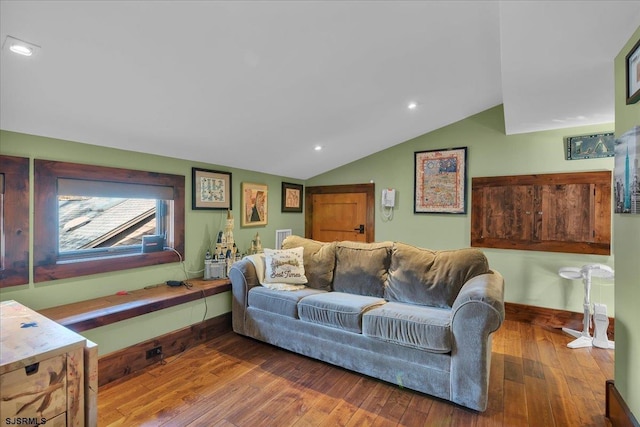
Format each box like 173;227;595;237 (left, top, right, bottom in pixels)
0;156;29;288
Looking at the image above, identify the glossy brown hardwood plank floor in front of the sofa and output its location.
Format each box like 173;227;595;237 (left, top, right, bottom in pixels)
98;320;614;427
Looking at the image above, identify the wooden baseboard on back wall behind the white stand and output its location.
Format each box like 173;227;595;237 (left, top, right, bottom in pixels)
504;302;615;341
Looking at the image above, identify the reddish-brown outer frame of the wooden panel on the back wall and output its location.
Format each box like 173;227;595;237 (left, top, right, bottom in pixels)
471;171;612;255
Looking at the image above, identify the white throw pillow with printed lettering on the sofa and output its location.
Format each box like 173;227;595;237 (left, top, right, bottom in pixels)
264;247;307;285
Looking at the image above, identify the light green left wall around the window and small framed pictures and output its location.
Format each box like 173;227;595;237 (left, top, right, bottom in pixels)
0;131;304;355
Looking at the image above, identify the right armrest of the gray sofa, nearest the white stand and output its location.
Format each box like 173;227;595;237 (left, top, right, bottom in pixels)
451;271;504;411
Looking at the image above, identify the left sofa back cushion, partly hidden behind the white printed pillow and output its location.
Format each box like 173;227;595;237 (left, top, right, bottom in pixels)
282;236;336;291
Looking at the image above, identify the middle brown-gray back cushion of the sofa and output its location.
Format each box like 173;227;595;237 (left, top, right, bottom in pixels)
333;241;393;298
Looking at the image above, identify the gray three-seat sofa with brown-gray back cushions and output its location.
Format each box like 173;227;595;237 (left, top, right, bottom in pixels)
229;236;504;411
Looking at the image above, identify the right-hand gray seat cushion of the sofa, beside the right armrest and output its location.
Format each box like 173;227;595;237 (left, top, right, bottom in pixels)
362;302;451;353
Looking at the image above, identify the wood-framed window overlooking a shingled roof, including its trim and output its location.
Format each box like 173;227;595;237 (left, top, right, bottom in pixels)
34;160;184;282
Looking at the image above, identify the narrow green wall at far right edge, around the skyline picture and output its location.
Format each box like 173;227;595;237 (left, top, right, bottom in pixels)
613;27;640;419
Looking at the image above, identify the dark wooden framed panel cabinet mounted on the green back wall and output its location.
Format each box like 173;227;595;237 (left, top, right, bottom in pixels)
471;171;611;255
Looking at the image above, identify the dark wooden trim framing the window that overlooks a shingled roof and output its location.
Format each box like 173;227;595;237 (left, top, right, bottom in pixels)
33;159;185;282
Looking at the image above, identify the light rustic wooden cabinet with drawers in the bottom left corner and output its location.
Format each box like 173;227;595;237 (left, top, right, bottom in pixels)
0;301;97;426
